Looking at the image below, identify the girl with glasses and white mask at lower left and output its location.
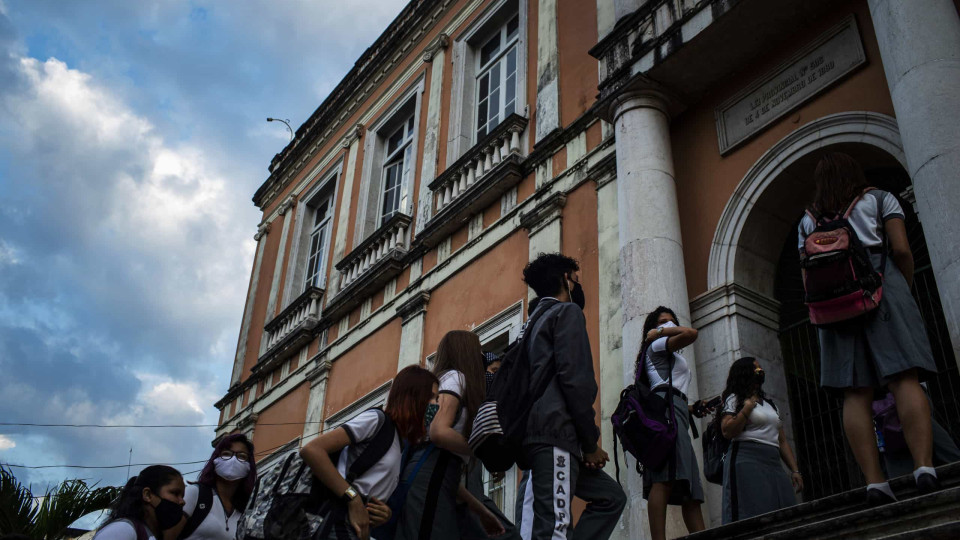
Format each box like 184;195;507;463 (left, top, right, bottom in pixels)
164;433;257;540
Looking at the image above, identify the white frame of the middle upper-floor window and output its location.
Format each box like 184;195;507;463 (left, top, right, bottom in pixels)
353;74;425;245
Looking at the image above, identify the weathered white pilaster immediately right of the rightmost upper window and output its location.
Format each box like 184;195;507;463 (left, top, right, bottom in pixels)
536;0;560;142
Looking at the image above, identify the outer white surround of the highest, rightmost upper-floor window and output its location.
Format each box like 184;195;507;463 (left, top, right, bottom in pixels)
446;0;535;166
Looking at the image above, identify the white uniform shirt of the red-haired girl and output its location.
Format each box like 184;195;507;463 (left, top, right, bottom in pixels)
337;409;402;502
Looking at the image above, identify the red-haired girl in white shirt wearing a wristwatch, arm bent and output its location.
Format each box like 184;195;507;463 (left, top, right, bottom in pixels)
300;366;439;540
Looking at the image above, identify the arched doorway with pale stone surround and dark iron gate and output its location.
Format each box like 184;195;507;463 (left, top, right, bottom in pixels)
691;112;960;500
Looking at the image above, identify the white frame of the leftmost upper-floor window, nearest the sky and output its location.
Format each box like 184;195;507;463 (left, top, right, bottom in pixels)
283;165;342;308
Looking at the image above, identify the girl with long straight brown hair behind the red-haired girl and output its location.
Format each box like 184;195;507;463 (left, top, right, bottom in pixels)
396;330;504;540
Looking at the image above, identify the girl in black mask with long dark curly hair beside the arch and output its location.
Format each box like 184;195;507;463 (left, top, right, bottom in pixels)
718;357;803;524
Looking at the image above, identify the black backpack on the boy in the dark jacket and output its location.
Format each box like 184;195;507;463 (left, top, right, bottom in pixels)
468;306;553;472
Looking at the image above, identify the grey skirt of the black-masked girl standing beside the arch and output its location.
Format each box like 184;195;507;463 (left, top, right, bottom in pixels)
723;441;797;524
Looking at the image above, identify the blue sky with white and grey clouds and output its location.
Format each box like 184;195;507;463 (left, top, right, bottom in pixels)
0;0;404;516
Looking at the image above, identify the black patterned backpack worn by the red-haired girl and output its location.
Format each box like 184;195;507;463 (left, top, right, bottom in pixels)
237;409;397;540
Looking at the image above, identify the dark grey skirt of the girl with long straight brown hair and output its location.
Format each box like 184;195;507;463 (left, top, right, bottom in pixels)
395;448;463;540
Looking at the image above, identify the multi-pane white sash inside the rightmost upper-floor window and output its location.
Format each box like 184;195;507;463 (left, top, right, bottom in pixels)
473;13;520;144
